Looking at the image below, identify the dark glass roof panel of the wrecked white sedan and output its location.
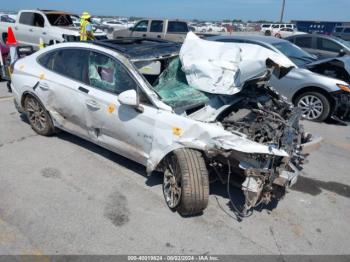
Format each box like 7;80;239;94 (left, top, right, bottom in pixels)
91;38;181;60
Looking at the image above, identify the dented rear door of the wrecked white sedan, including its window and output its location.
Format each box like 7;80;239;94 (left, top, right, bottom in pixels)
36;48;89;139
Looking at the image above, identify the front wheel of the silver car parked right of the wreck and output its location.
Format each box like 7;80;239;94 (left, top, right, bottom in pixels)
295;91;331;122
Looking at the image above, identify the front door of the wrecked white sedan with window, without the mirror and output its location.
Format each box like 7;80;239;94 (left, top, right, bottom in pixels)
82;51;157;165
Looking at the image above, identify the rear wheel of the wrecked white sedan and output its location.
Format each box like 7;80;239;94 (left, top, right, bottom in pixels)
24;95;55;136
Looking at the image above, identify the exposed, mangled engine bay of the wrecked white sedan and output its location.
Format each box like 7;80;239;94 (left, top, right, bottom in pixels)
214;74;311;216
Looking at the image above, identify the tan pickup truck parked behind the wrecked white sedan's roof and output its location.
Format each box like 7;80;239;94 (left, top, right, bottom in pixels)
113;19;189;42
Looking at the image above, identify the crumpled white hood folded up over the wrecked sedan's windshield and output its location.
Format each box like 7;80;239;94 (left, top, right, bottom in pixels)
180;32;294;95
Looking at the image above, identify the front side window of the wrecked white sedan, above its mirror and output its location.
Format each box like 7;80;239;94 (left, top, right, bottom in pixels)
88;52;137;94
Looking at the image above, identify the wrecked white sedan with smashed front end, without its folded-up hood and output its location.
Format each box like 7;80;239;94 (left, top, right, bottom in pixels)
12;36;317;215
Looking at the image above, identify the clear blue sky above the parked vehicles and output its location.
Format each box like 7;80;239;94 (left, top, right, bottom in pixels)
0;0;350;21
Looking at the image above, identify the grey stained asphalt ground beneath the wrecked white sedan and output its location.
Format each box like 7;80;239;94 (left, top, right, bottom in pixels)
0;82;350;255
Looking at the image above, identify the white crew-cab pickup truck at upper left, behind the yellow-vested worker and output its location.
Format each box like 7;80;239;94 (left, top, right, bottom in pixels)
0;10;107;48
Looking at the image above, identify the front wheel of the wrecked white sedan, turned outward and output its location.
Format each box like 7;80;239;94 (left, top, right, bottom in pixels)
163;149;209;216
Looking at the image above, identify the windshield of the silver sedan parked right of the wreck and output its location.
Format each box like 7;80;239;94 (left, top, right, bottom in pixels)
272;42;317;66
